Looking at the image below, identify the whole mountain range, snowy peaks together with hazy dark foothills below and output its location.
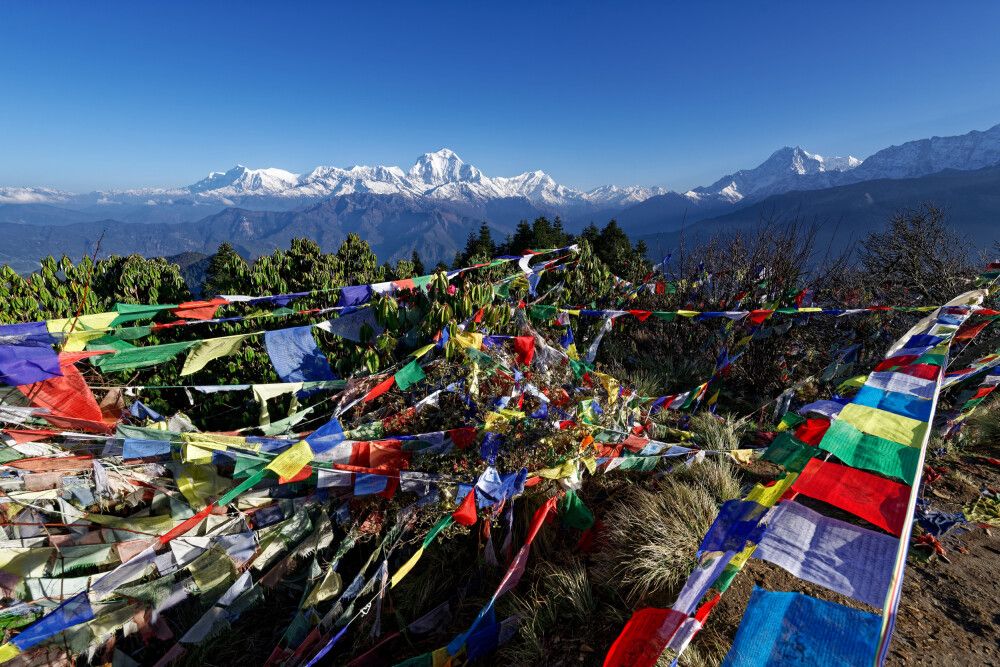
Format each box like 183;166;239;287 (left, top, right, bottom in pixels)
0;125;1000;271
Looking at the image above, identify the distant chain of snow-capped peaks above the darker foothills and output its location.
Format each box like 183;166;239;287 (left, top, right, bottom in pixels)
0;125;1000;230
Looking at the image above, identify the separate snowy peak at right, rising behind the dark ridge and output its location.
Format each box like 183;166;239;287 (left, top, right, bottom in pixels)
686;146;862;203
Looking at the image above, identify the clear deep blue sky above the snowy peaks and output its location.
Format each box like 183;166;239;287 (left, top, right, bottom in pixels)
0;0;1000;190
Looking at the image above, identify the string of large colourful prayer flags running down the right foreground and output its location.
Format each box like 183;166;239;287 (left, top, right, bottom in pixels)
609;290;986;665
